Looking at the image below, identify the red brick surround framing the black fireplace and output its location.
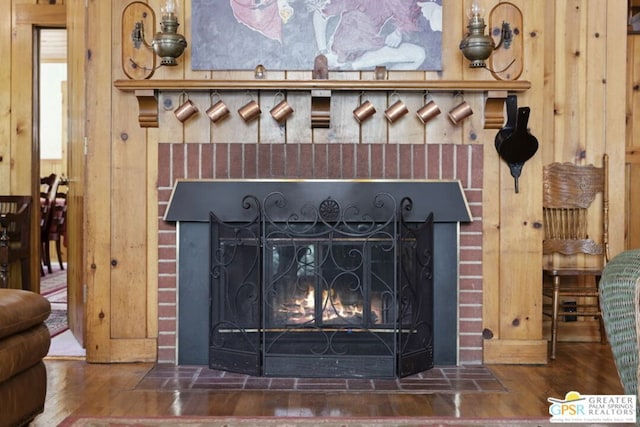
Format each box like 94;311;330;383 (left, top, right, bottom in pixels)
158;143;483;364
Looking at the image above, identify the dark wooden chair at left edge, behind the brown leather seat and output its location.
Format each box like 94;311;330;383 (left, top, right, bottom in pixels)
0;196;31;290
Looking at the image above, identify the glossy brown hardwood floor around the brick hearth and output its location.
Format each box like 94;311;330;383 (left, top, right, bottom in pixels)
33;343;624;426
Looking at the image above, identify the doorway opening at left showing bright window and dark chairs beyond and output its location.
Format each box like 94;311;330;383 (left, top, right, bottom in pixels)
34;28;84;356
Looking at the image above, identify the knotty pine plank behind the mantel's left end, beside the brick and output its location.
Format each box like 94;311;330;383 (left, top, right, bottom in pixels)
110;1;147;340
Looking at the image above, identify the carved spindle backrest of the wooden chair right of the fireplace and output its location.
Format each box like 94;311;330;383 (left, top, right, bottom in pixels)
542;154;609;262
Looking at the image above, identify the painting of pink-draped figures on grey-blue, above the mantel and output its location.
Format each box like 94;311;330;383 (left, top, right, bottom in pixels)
191;0;442;70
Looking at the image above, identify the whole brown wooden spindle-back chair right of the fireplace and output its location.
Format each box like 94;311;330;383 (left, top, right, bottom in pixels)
543;154;609;359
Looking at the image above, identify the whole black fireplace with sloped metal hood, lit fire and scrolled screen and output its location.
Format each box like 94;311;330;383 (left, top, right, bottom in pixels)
165;180;471;378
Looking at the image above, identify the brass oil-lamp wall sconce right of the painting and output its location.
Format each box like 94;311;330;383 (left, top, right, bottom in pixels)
460;0;513;68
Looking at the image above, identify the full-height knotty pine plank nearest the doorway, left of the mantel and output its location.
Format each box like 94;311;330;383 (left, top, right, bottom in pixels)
83;1;115;362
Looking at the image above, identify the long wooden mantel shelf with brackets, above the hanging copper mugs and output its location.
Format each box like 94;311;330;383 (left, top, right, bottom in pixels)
114;79;531;129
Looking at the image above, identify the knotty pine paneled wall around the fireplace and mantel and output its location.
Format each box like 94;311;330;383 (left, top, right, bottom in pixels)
0;0;626;363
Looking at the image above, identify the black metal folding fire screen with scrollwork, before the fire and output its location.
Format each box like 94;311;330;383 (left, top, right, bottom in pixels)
209;191;433;378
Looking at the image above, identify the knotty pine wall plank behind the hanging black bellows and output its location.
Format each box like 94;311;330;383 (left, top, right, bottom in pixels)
492;1;545;347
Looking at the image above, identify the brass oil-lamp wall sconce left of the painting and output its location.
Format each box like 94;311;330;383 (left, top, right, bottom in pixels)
131;0;187;68
